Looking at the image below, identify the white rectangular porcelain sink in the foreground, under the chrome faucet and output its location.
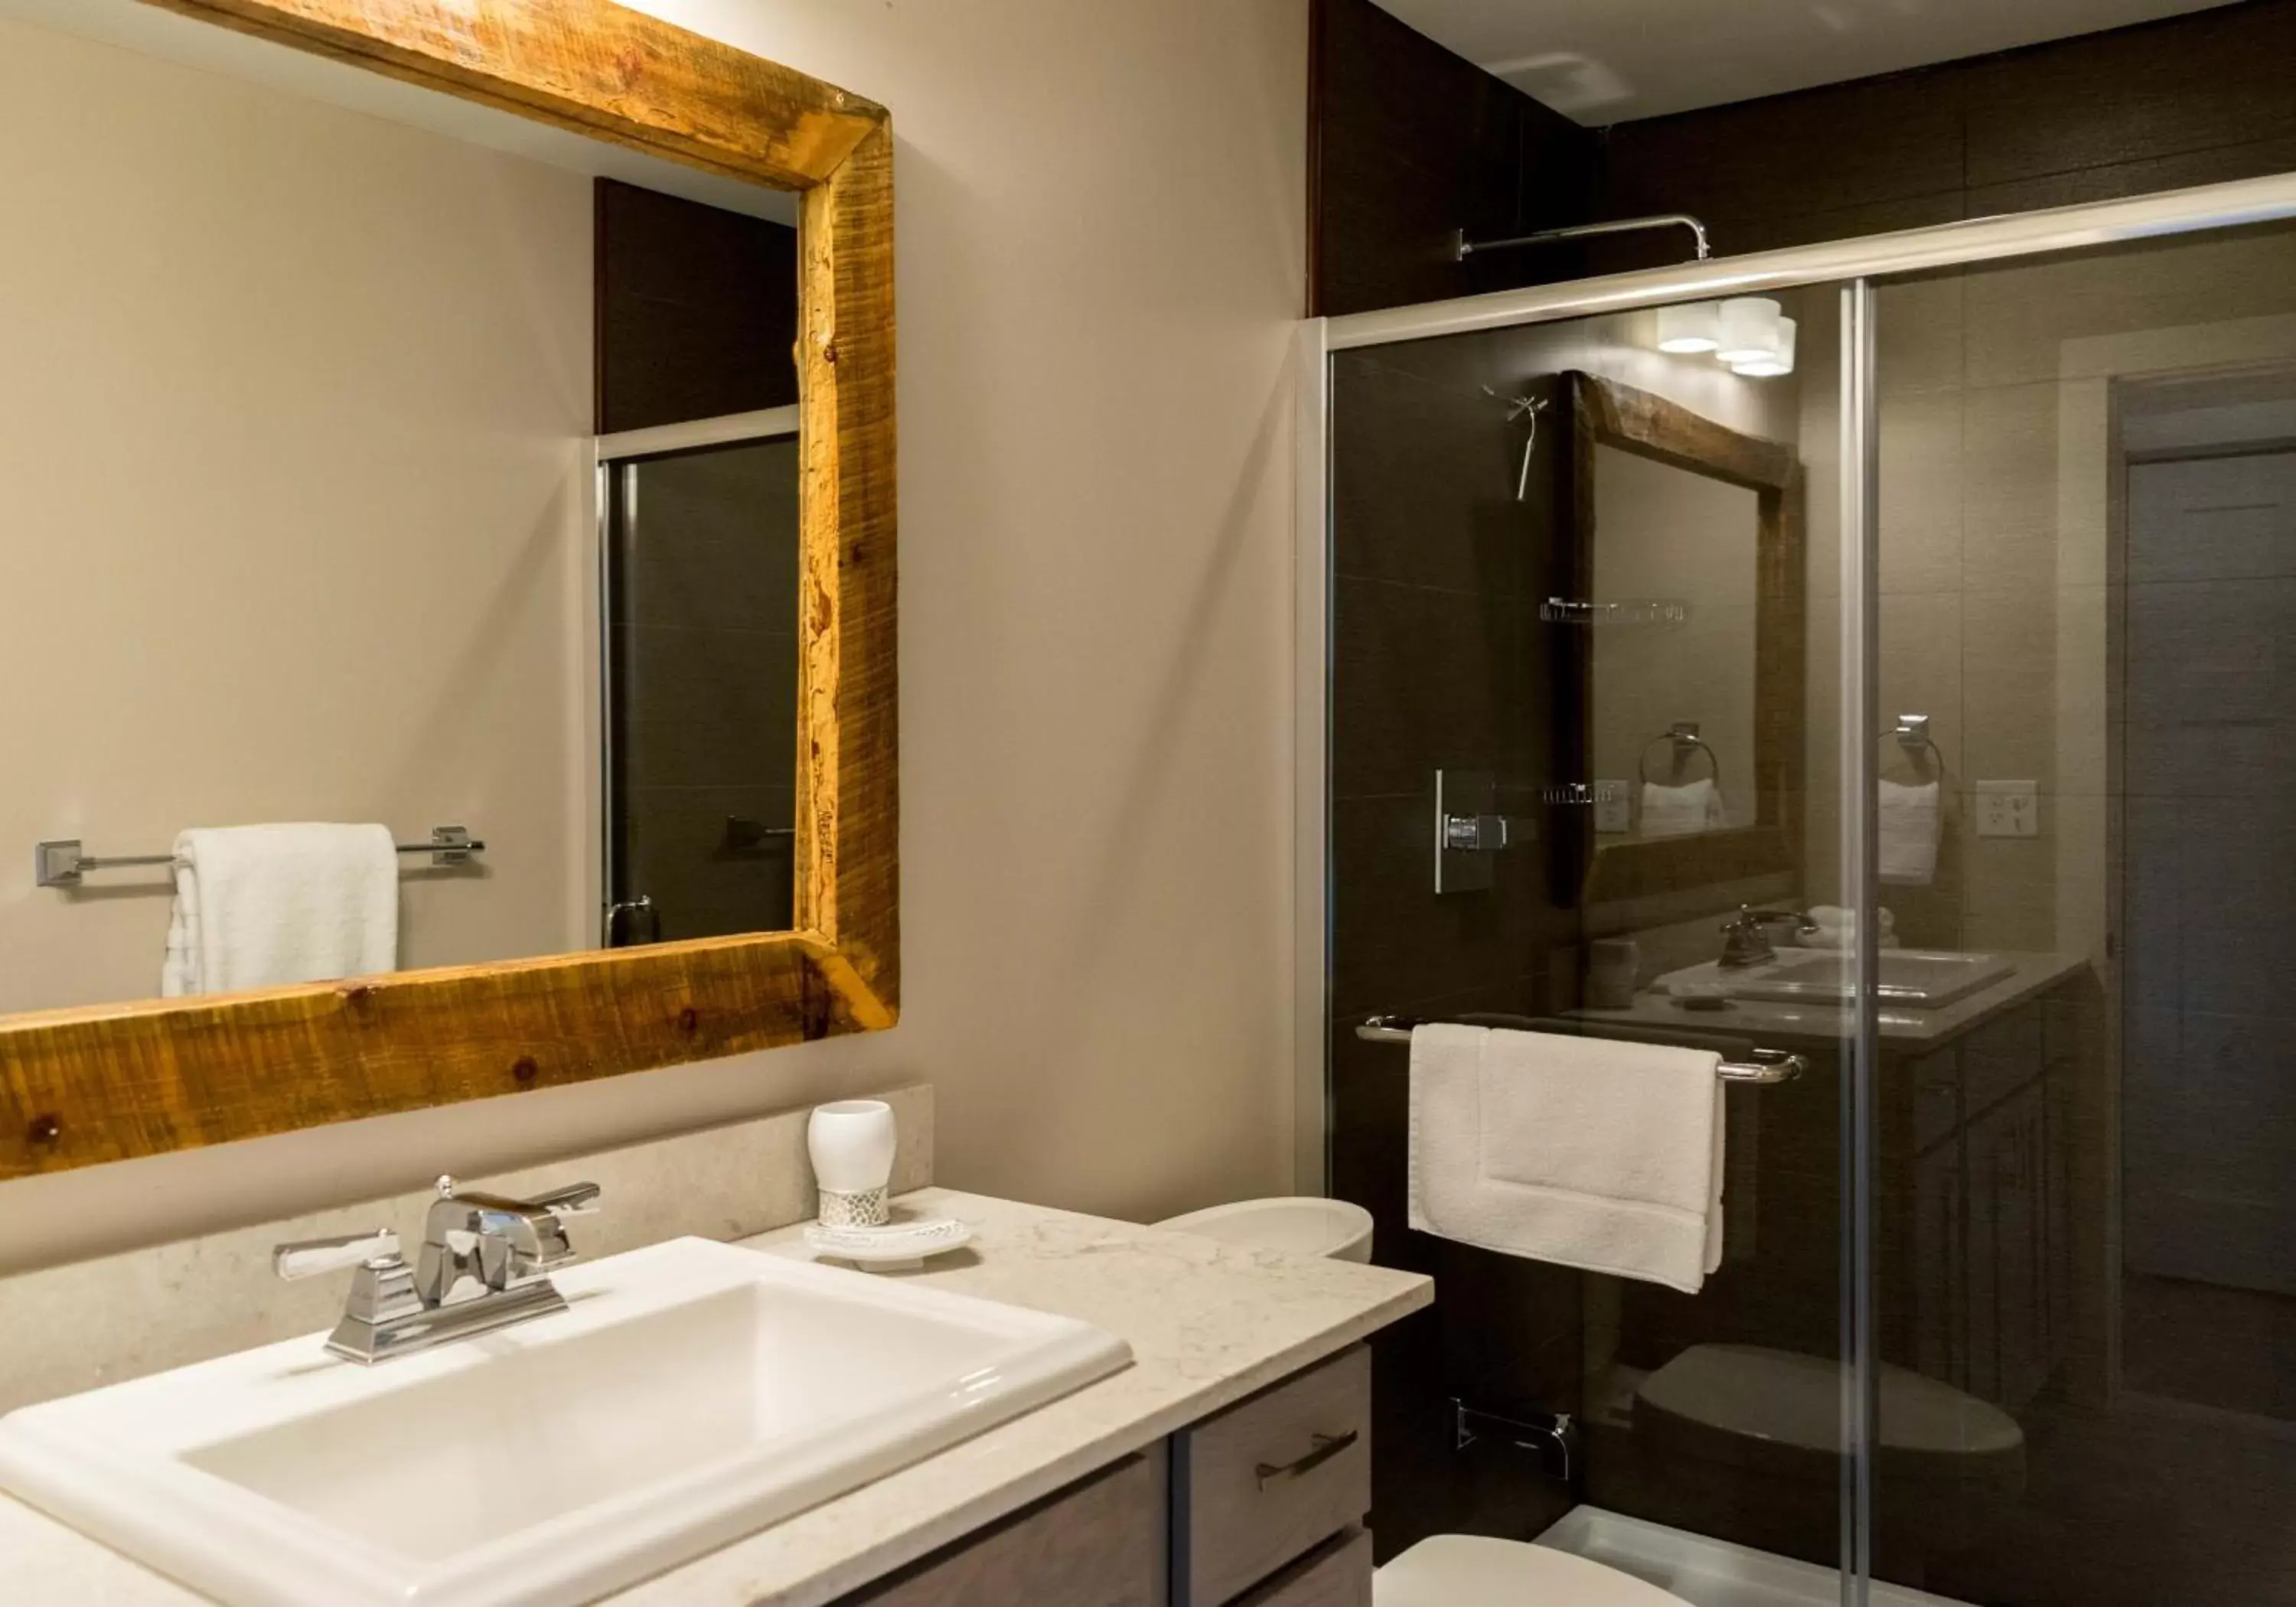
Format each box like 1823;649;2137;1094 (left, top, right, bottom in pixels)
0;1240;1132;1607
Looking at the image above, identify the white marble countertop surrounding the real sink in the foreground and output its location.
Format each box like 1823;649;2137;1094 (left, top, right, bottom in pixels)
0;1189;1433;1607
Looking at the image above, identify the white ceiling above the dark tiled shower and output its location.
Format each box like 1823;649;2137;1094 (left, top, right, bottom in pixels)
1378;0;2227;126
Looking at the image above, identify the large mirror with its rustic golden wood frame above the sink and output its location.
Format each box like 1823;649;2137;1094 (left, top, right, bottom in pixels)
0;0;898;1175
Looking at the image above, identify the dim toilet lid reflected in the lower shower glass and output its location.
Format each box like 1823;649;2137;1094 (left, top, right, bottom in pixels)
1635;1345;2025;1472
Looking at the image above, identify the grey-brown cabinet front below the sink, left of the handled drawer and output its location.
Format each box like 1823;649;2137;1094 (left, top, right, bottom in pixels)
838;1446;1166;1607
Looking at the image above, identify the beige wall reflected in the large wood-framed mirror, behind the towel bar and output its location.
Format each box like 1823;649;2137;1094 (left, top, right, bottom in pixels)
0;21;590;1015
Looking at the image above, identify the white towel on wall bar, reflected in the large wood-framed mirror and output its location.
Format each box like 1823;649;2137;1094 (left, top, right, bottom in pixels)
161;824;400;999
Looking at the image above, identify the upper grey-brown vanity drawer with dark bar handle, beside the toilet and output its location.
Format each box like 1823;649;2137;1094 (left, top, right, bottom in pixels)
1171;1345;1371;1607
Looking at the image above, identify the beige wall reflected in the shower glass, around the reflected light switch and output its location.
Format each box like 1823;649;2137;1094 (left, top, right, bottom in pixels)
1800;227;2296;969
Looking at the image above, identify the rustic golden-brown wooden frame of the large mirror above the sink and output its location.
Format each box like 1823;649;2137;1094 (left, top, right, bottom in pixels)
0;0;900;1178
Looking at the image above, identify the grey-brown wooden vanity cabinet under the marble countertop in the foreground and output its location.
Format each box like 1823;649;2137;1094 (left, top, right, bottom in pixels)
838;1345;1371;1607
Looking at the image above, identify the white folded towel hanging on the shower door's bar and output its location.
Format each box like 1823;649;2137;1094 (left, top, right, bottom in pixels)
1410;1024;1722;1295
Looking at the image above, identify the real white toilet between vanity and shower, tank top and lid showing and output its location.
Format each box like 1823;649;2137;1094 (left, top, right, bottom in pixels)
1155;1198;1683;1607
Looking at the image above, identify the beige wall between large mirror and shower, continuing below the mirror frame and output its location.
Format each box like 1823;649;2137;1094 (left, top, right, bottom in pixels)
0;0;1306;1265
